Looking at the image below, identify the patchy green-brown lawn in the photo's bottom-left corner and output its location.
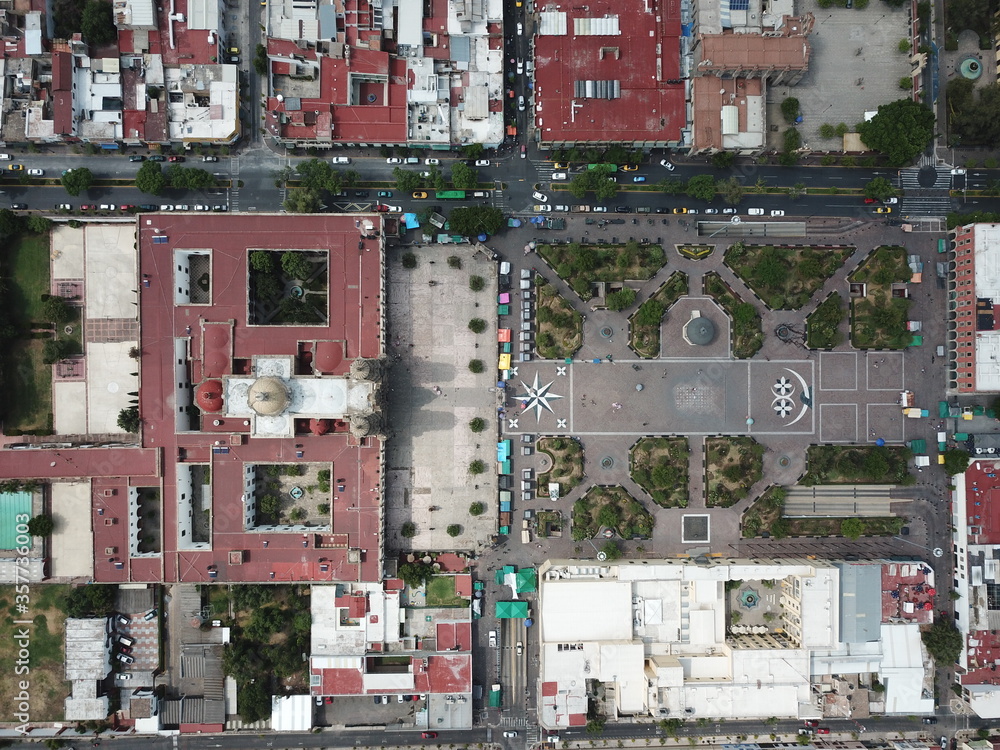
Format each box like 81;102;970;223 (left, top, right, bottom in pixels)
0;584;71;722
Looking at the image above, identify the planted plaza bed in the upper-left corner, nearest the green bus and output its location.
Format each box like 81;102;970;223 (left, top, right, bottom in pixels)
538;242;665;301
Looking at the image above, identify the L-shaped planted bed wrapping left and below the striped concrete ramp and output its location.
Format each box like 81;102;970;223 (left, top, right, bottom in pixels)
740;485;906;539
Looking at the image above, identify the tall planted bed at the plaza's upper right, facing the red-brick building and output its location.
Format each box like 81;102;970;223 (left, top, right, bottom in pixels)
848;246;912;349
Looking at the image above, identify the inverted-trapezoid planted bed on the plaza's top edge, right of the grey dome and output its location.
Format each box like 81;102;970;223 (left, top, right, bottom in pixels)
725;242;854;310
